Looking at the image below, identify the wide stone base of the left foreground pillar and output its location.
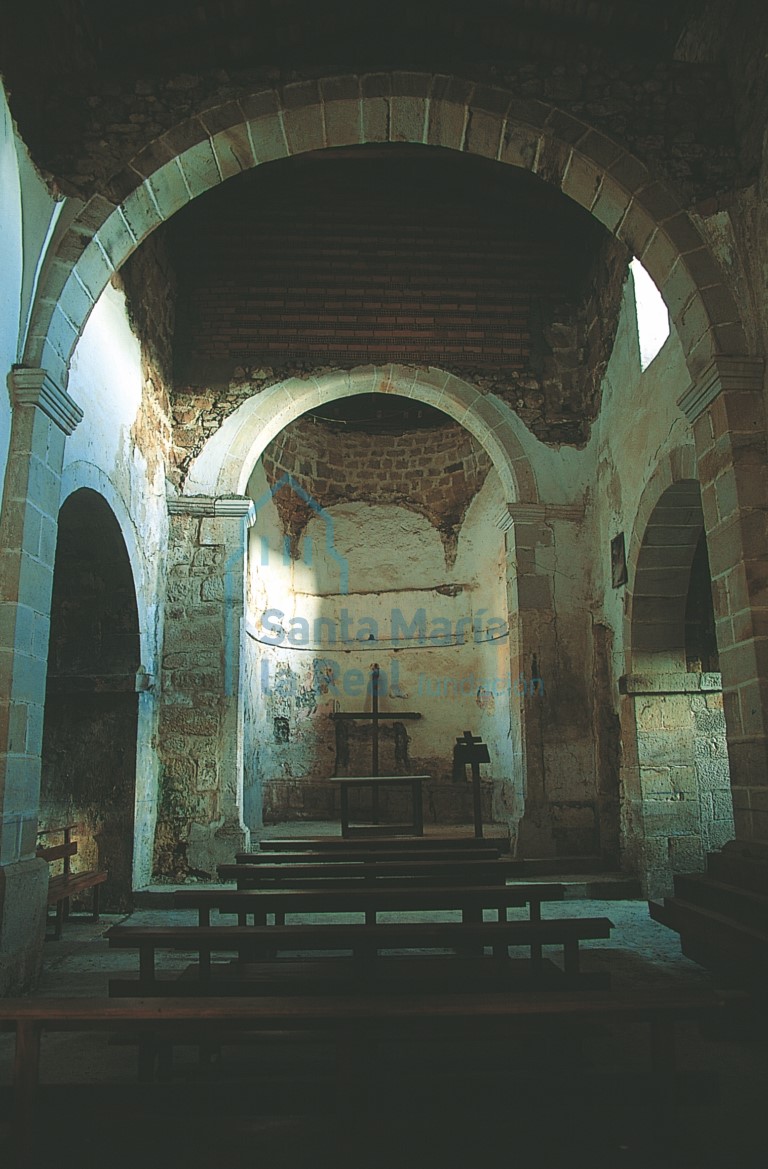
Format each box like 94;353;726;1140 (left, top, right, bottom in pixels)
0;857;48;995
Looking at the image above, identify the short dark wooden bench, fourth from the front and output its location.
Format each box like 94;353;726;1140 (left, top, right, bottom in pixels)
219;857;518;890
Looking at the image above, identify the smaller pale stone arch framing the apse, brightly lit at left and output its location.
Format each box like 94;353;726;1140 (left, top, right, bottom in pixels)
184;365;538;503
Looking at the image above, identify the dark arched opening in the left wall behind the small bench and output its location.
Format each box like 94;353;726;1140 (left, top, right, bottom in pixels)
40;489;140;912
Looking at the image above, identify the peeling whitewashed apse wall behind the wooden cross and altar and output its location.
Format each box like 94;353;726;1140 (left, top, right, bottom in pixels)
245;465;521;825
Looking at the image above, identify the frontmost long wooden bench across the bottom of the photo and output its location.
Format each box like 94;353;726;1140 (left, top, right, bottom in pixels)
0;990;748;1169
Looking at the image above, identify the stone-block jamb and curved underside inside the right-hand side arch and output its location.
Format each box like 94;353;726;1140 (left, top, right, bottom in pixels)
620;447;733;898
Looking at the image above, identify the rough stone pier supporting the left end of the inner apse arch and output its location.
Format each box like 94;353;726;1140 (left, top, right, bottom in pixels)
154;496;255;877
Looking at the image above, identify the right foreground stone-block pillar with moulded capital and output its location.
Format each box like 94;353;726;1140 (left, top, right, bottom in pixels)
679;357;768;860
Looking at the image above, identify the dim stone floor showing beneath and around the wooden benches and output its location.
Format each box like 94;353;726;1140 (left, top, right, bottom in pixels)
0;855;768;1169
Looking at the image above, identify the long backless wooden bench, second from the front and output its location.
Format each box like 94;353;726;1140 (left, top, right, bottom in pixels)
106;918;613;995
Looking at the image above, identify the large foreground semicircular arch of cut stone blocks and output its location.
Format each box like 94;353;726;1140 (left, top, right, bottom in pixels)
25;72;747;385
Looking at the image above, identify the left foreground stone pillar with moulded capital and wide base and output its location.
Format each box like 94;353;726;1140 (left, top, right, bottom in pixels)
0;369;83;994
